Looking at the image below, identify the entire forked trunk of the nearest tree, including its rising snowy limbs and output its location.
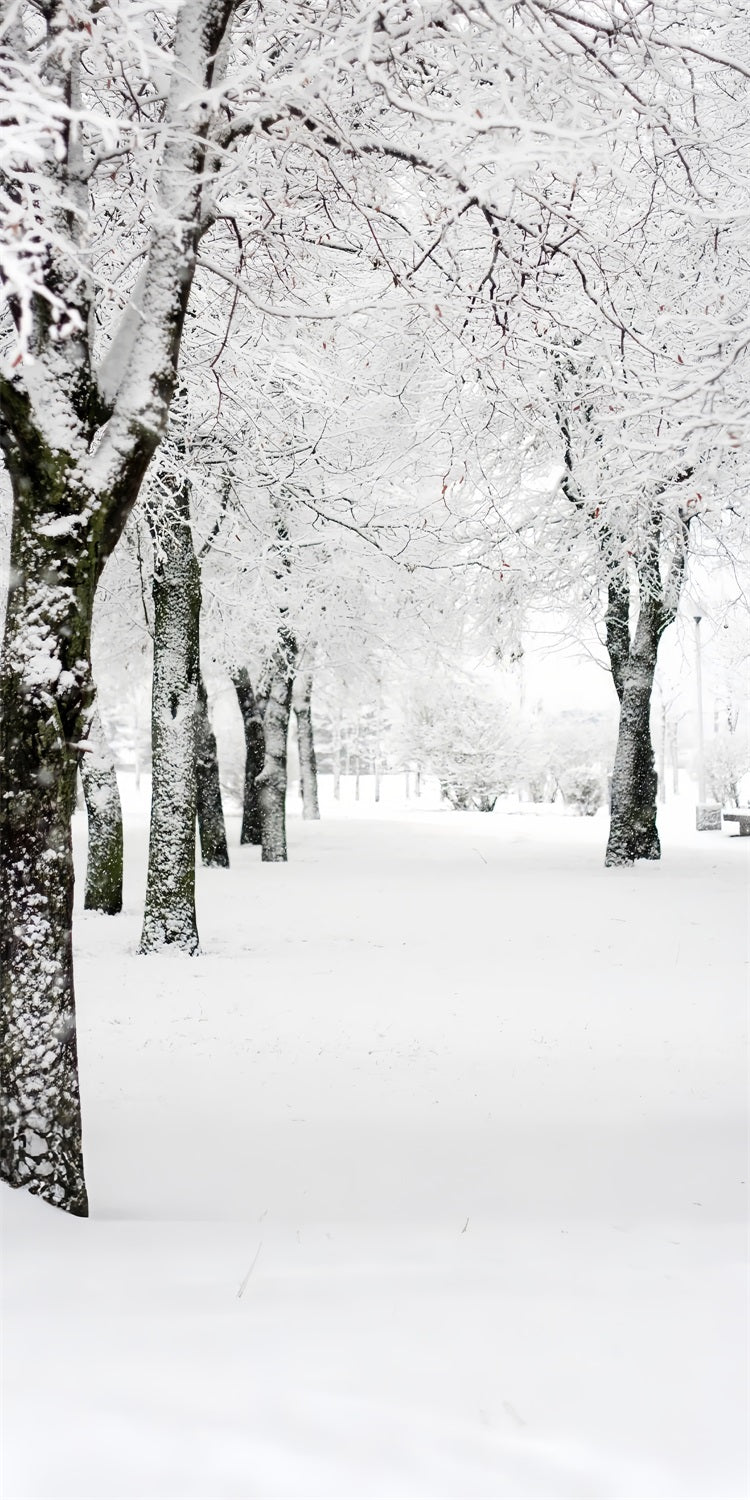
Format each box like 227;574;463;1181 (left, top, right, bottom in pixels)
0;0;233;1214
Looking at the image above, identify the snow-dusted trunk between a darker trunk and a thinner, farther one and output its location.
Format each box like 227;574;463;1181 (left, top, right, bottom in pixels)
255;632;296;864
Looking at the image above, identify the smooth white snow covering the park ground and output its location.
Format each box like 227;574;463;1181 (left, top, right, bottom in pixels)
2;788;749;1500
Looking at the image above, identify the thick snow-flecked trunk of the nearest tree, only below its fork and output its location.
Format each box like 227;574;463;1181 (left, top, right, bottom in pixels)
0;486;96;1215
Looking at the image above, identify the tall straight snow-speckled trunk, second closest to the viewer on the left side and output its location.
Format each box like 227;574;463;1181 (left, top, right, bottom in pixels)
140;498;201;953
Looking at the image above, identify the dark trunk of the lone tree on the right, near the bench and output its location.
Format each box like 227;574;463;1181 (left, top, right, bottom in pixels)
605;606;662;866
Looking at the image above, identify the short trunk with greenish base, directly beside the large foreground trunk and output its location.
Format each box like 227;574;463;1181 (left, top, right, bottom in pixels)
81;704;123;917
